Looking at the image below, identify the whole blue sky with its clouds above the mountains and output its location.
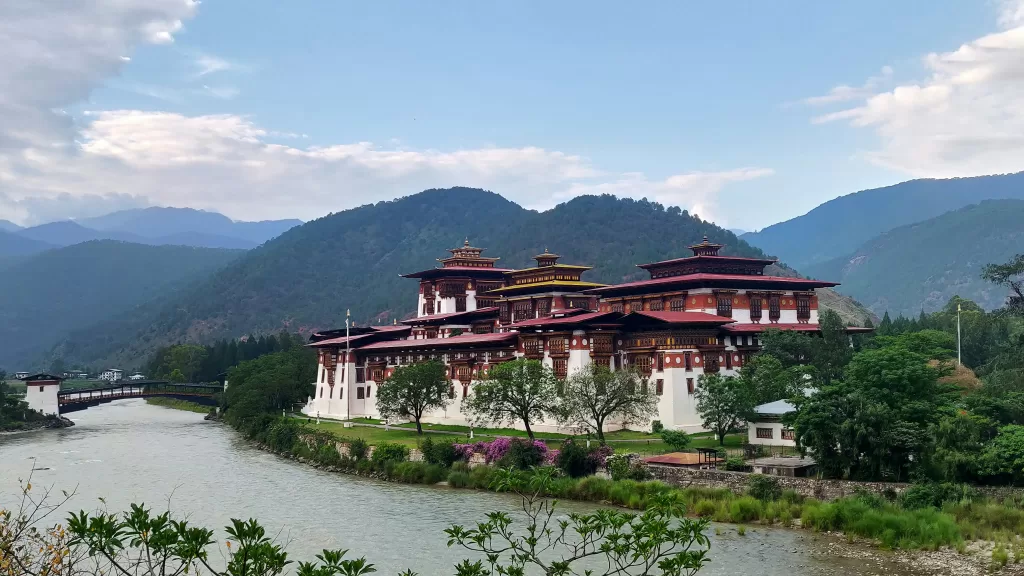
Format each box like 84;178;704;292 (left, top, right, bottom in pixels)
0;0;1024;230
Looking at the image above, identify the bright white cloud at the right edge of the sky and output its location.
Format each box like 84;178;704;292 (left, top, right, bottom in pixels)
808;5;1024;177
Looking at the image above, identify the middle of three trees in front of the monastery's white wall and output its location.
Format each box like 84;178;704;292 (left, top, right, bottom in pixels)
462;359;558;440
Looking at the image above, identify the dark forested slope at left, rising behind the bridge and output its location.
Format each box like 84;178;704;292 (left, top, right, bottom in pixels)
0;240;242;371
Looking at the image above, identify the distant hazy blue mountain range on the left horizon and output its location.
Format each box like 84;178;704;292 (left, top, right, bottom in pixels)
0;207;302;253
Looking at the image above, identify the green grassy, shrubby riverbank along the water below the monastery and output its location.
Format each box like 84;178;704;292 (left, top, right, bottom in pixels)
226;409;1024;574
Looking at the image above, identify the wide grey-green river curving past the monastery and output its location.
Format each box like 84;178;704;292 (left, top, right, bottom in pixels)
0;400;919;576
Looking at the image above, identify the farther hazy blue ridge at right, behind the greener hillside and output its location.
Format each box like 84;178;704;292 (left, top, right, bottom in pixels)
741;172;1024;271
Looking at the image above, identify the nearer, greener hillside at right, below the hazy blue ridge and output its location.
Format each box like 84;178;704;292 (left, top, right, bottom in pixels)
803;200;1024;316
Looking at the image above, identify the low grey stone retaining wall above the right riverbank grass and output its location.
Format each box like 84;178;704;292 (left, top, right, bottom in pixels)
647;464;1024;500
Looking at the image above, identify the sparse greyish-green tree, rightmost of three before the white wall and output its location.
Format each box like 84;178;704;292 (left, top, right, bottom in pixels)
557;362;657;444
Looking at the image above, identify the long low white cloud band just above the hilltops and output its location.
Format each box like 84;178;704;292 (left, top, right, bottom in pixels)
0;111;772;224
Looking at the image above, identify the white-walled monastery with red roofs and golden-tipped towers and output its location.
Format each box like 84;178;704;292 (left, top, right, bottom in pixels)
303;237;860;431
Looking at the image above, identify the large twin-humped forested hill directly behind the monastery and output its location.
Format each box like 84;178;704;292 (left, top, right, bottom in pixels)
49;189;863;362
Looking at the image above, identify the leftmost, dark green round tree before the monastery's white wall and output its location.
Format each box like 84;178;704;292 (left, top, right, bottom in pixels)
377;360;451;434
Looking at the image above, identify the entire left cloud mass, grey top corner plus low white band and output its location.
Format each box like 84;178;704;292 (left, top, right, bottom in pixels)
0;0;771;223
